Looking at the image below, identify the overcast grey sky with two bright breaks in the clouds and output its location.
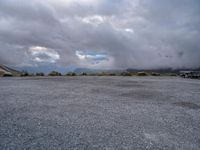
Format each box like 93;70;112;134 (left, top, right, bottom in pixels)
0;0;200;69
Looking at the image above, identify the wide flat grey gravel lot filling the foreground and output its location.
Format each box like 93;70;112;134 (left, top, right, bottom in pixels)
0;77;200;150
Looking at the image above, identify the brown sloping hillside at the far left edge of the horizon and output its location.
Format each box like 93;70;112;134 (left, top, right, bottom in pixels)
0;65;21;76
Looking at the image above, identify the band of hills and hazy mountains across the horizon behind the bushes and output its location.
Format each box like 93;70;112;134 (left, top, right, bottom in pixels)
0;65;200;76
